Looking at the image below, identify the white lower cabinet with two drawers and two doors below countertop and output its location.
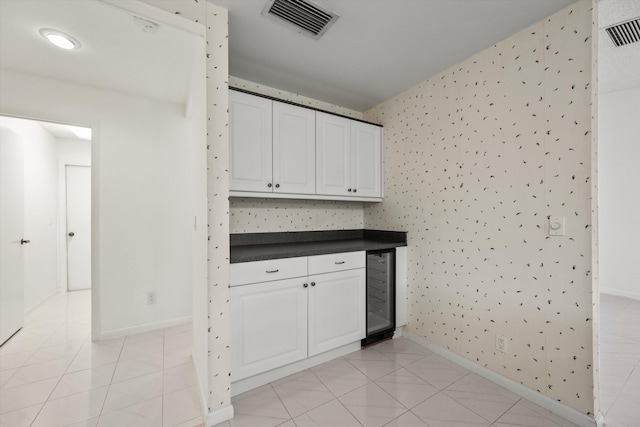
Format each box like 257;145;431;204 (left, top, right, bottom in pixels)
230;252;366;386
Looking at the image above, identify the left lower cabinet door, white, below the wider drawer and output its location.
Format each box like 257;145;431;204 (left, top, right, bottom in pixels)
231;278;308;381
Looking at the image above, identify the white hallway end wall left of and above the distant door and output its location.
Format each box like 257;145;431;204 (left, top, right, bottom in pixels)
56;138;91;292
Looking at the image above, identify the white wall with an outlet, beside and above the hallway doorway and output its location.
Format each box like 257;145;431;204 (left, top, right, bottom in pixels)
0;70;200;339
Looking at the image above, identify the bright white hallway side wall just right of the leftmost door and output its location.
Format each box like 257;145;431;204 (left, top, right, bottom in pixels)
0;117;58;312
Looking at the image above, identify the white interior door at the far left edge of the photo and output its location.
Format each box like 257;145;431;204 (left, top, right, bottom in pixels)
0;127;27;344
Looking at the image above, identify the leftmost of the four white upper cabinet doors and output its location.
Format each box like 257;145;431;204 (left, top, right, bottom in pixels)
229;91;273;193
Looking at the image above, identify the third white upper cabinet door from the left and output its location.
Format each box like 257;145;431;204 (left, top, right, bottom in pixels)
316;112;352;196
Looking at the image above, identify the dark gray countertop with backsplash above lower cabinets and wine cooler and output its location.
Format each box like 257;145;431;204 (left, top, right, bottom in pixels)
231;230;407;263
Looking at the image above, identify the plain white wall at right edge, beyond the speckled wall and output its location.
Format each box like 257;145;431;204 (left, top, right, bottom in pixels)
598;87;640;300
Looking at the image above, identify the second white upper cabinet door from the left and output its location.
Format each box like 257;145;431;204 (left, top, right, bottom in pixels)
273;101;316;194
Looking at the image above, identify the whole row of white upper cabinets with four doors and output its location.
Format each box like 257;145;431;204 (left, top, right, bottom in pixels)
229;90;382;202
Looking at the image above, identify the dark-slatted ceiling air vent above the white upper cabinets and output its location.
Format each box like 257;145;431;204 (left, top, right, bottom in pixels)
262;0;338;40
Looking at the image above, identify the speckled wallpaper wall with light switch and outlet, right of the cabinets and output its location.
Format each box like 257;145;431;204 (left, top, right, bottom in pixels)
364;0;595;414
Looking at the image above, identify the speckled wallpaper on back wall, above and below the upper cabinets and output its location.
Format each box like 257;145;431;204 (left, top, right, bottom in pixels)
229;76;363;233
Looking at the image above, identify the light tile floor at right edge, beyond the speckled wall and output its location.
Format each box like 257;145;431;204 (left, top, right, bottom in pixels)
600;294;640;427
